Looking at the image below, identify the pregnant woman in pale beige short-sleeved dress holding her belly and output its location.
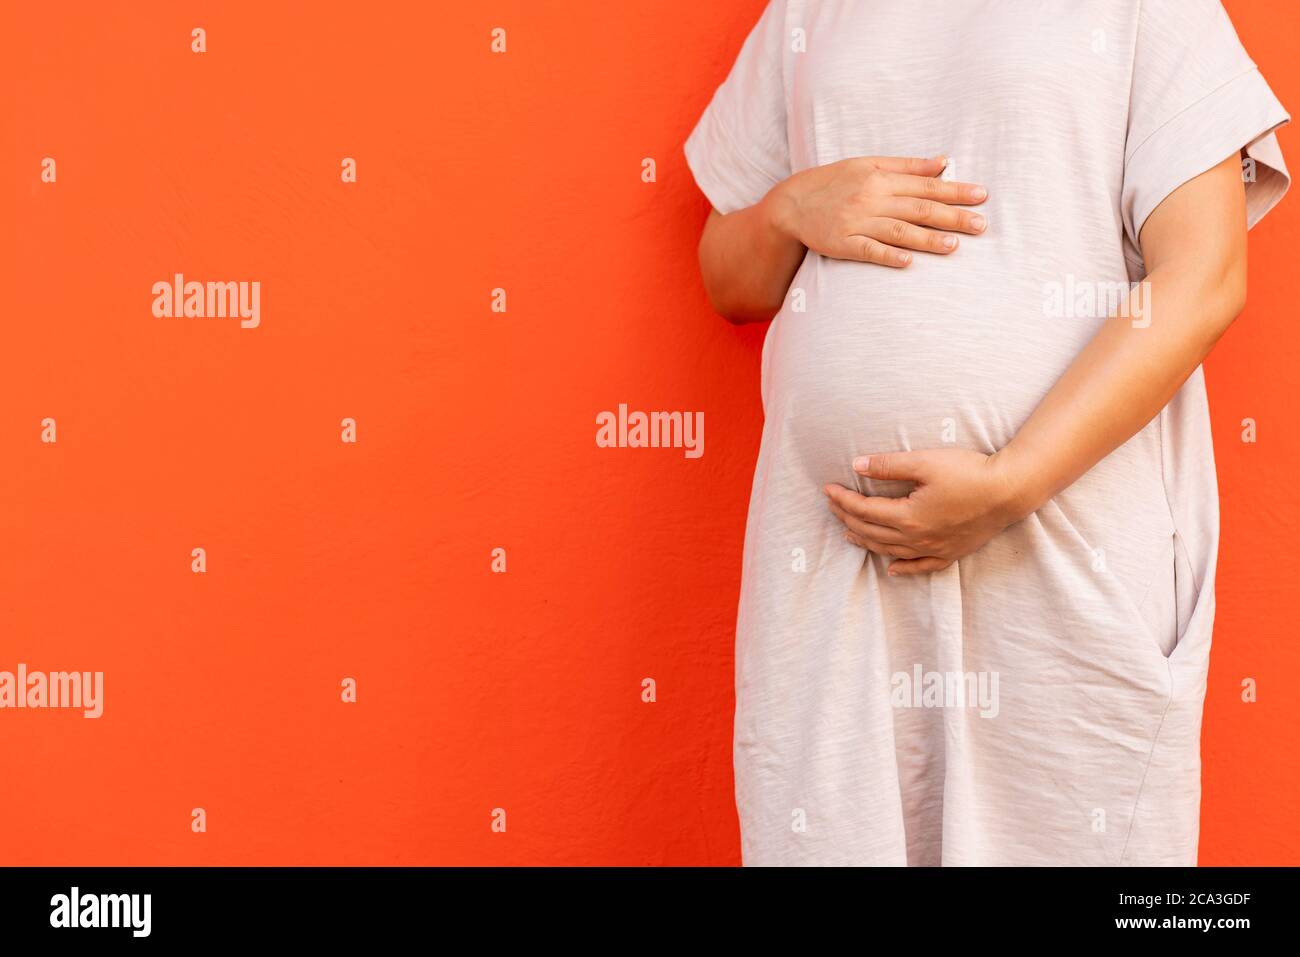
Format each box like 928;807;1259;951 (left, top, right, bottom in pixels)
685;0;1290;865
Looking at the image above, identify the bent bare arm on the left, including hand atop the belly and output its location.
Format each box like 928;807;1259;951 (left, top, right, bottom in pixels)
699;156;985;322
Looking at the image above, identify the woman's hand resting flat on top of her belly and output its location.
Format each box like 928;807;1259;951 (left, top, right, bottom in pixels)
763;156;988;268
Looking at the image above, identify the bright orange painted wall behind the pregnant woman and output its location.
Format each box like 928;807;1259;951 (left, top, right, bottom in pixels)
0;0;1300;865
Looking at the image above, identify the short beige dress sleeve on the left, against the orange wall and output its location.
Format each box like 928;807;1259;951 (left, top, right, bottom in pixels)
684;0;790;213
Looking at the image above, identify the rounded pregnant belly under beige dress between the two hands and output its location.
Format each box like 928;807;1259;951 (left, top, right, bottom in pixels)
763;255;1100;481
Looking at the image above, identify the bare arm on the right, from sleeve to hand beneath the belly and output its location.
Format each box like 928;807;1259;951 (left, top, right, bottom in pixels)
826;155;1247;575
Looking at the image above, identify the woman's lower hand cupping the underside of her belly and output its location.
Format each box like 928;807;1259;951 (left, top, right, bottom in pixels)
824;449;1024;575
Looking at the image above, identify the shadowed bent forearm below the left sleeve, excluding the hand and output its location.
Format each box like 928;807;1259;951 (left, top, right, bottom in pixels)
699;191;806;322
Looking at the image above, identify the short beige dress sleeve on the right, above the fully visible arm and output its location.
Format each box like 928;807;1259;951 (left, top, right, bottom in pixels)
1121;0;1291;250
